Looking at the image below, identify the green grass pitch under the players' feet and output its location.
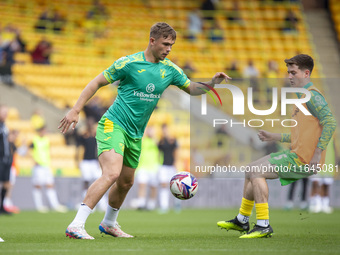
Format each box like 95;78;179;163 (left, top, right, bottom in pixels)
0;209;340;255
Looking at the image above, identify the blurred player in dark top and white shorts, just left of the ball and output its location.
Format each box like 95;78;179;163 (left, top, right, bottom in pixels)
158;124;178;213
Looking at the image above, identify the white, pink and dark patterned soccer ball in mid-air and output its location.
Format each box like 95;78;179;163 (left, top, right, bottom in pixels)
170;172;198;200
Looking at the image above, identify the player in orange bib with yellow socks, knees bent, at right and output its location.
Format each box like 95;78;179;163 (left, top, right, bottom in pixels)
217;54;336;238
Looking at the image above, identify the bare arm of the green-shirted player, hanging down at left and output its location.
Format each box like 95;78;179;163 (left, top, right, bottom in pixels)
58;73;108;134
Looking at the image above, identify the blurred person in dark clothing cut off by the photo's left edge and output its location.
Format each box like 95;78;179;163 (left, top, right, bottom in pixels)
0;105;13;215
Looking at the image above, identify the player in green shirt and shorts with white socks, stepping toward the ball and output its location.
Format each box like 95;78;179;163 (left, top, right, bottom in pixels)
58;23;230;239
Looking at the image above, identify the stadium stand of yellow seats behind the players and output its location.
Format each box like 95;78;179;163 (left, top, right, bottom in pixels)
0;0;326;175
